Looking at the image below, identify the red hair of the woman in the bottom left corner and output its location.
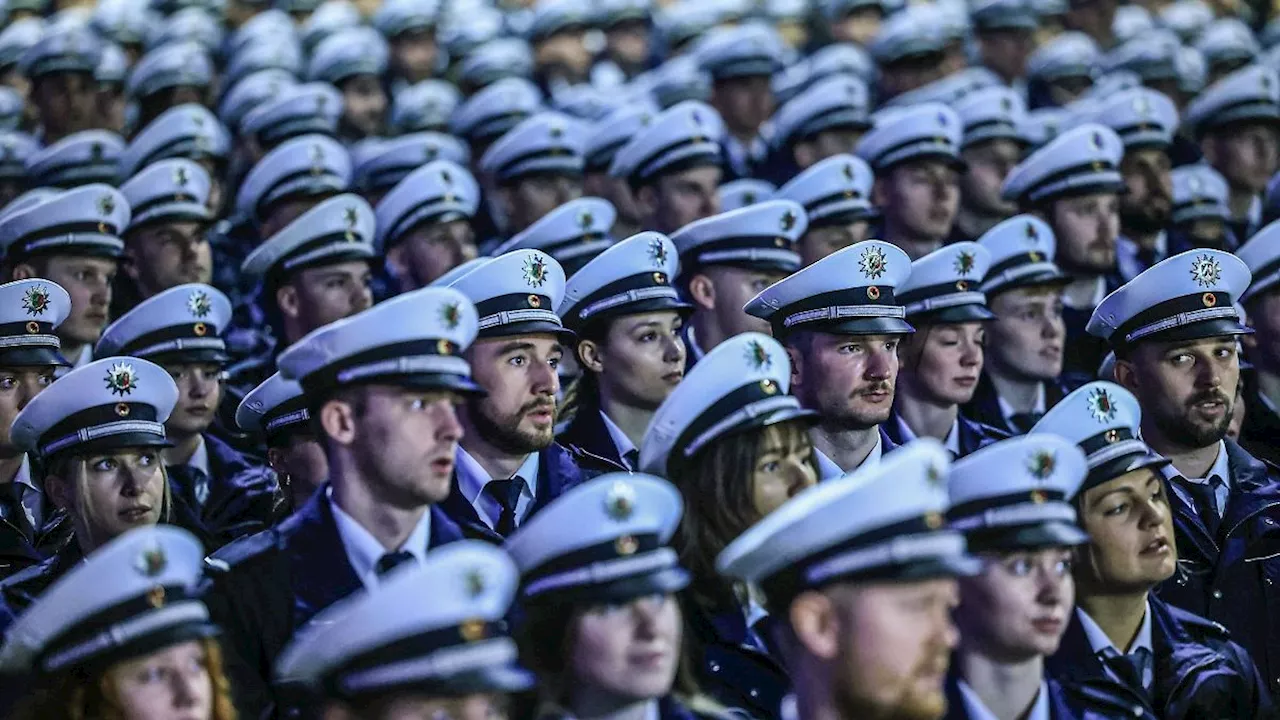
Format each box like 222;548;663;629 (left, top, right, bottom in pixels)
15;638;238;720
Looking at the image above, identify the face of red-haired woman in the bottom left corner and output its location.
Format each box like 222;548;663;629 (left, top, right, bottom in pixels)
106;641;214;720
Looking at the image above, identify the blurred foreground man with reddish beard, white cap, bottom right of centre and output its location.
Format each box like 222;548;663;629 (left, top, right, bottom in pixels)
717;439;978;720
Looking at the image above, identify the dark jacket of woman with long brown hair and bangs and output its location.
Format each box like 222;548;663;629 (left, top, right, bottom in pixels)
681;597;791;720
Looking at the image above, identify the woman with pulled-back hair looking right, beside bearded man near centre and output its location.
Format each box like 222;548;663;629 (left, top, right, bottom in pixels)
556;232;692;471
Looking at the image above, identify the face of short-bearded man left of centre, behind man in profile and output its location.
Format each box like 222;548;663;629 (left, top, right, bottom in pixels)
465;334;564;454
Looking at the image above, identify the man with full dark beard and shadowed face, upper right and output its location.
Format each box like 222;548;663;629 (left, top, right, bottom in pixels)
1093;87;1178;281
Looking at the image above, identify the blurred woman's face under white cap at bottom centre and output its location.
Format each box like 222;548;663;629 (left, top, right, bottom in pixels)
568;594;681;702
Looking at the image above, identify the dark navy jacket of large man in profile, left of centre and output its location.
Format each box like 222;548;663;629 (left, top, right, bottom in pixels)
204;483;462;717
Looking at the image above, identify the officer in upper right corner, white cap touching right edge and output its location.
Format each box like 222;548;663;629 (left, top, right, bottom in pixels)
1184;65;1280;240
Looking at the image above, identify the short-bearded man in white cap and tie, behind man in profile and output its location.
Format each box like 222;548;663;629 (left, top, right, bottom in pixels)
443;250;582;544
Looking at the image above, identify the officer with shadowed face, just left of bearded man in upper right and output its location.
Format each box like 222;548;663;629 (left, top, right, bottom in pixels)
951;86;1027;242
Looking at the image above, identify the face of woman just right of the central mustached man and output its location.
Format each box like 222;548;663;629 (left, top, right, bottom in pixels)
899;323;987;405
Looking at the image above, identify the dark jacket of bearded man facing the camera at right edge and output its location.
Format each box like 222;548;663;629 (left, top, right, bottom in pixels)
1156;439;1280;694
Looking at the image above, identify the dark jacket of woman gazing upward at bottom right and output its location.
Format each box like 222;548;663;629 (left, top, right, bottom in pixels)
1047;597;1275;720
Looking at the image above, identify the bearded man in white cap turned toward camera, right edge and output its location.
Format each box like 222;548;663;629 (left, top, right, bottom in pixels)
1088;250;1280;692
